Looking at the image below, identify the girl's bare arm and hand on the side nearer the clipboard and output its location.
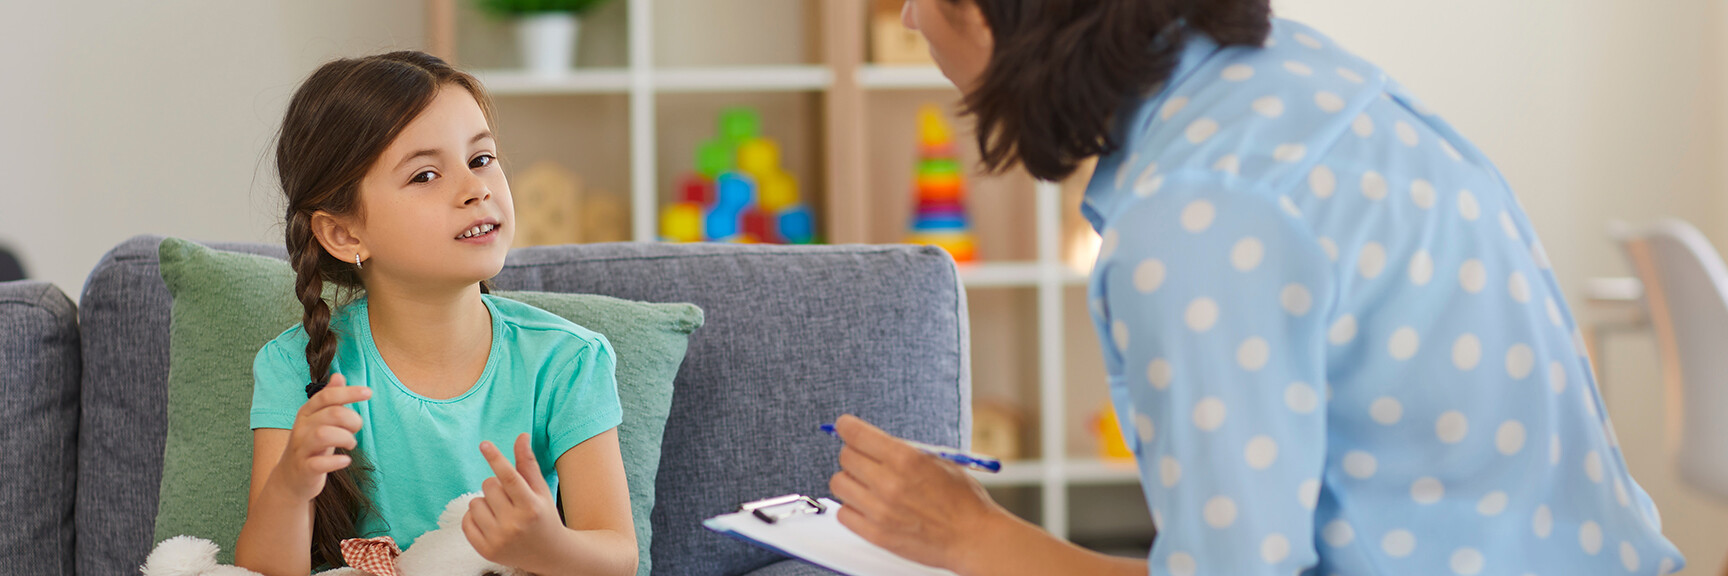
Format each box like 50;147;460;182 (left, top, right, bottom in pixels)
461;429;636;576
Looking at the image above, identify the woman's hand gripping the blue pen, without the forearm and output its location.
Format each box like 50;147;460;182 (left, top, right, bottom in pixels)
828;415;1009;573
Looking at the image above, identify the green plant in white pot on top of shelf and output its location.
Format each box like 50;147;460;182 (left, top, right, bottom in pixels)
479;0;607;76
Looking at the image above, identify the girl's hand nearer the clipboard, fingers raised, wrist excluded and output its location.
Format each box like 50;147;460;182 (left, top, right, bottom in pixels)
461;434;565;573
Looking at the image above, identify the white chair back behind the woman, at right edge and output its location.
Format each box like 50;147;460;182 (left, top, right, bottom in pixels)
1610;220;1728;498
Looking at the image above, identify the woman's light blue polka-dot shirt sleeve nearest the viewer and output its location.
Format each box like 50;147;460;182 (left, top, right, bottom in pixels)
1101;183;1332;576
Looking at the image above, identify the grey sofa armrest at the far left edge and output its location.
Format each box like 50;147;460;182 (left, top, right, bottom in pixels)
0;280;78;576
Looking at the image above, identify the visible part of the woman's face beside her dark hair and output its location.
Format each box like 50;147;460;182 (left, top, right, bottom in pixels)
900;0;995;92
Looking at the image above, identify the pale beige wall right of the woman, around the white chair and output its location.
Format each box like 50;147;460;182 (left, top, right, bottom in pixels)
1274;0;1728;574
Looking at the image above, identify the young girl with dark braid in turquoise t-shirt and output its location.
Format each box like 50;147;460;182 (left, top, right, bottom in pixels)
235;52;636;576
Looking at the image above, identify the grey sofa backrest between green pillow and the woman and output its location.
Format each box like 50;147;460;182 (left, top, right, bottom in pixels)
496;244;971;574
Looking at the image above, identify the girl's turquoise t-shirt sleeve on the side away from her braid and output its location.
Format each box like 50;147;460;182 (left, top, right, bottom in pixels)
541;334;624;460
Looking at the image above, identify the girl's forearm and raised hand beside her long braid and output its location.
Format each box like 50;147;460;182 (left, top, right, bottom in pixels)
233;375;372;576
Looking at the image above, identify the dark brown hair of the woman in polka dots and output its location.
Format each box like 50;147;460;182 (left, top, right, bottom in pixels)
943;0;1272;180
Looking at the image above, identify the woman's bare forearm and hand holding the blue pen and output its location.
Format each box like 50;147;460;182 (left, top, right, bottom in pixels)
829;415;1146;576
